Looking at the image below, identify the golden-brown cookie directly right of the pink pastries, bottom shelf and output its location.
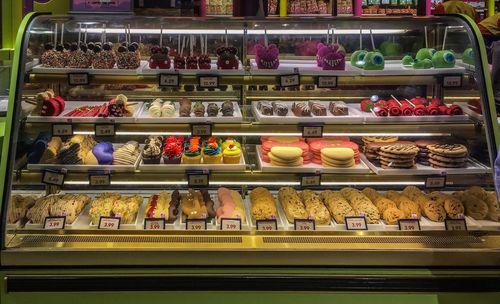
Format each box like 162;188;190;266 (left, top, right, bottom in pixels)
250;187;278;224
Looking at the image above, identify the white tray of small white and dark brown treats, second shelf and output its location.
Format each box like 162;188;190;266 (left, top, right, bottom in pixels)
136;102;243;123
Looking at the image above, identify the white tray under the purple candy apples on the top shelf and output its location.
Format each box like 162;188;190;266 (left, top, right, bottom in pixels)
250;59;361;76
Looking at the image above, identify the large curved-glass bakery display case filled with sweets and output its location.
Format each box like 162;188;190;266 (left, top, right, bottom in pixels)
1;14;500;303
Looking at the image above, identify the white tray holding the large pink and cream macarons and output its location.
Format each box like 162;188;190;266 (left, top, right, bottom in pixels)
256;145;371;174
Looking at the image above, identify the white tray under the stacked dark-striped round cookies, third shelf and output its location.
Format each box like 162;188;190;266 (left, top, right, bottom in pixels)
359;153;491;176
